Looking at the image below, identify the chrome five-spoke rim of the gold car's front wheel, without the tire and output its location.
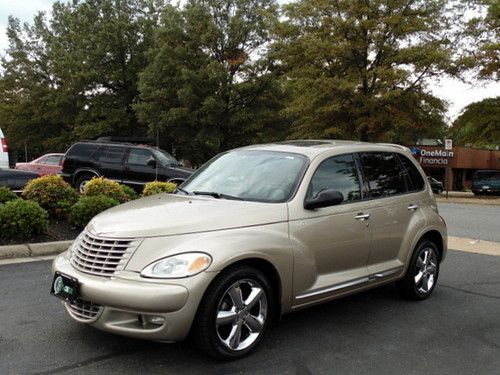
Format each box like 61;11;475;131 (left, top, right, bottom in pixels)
216;279;268;351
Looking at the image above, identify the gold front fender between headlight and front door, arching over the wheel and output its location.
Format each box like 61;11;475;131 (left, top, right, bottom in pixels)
126;222;293;312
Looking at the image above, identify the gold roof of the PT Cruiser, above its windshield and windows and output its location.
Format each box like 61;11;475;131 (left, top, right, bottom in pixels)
240;139;410;159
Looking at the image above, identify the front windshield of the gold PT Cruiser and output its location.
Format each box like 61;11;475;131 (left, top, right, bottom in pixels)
181;150;308;203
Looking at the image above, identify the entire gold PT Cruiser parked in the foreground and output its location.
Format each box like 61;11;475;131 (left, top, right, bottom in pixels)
52;140;447;359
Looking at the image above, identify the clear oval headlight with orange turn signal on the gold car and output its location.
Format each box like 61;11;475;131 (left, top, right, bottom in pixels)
141;253;212;279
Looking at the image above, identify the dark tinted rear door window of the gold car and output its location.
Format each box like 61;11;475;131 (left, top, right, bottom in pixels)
361;152;407;198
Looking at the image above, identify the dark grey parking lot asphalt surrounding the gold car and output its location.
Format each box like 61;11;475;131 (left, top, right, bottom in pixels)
0;251;500;374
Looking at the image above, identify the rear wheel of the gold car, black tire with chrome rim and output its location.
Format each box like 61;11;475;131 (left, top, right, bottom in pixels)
397;240;439;301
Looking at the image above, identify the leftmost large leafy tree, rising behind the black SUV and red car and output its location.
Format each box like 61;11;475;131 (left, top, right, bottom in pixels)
0;0;163;158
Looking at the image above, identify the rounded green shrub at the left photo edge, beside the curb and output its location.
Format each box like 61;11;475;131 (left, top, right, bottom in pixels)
0;199;49;238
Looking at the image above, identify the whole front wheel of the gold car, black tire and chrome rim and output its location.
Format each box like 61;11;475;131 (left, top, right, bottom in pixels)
192;266;274;360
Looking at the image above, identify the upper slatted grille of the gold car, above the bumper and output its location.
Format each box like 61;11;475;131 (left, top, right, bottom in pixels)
70;232;138;276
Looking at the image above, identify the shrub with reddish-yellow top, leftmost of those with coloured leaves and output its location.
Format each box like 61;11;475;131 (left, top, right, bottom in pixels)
22;175;78;218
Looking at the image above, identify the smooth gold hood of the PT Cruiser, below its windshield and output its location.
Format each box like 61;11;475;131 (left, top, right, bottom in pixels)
87;194;288;238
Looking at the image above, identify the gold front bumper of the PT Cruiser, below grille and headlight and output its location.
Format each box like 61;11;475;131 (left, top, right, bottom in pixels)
52;252;216;342
